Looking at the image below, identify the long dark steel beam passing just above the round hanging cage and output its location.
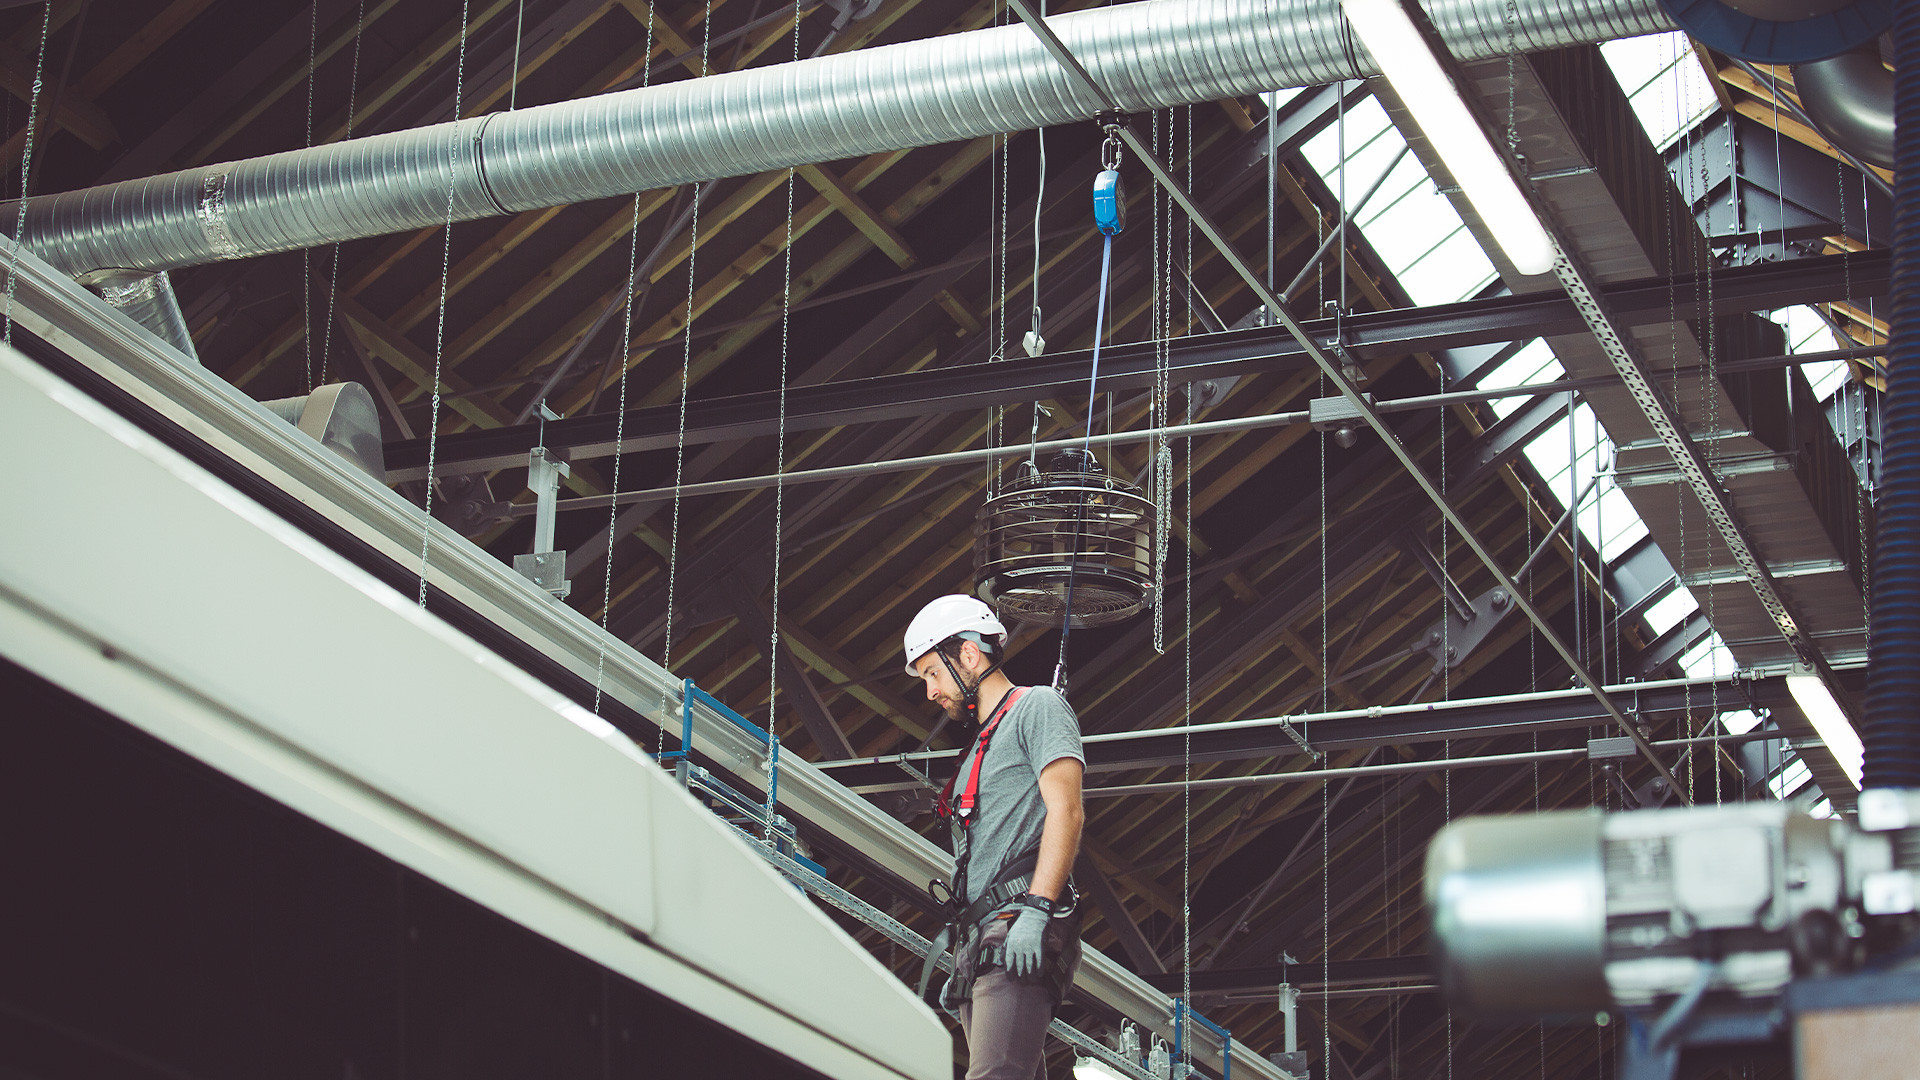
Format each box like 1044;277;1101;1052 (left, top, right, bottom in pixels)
386;250;1891;480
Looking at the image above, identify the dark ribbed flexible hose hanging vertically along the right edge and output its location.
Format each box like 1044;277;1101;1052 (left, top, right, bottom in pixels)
1862;4;1920;788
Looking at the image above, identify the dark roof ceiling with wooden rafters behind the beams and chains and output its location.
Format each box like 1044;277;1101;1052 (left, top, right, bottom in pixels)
0;0;1873;1080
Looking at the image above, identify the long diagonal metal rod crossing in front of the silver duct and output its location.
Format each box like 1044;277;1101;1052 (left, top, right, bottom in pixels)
1008;0;1692;805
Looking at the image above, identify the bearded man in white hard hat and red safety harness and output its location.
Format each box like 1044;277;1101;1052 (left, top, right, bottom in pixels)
904;596;1087;1080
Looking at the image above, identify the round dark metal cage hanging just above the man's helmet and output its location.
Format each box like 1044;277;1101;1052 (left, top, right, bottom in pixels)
973;461;1154;628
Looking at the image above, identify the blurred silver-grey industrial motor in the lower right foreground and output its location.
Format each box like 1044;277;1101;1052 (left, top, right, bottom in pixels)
1427;790;1920;1017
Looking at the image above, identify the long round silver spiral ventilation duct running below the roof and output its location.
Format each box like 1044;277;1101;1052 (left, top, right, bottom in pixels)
0;0;1672;273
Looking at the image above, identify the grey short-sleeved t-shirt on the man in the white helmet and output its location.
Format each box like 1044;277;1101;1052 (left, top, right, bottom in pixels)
952;686;1087;903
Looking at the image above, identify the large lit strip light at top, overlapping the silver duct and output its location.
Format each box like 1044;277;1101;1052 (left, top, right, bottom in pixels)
1340;0;1553;275
